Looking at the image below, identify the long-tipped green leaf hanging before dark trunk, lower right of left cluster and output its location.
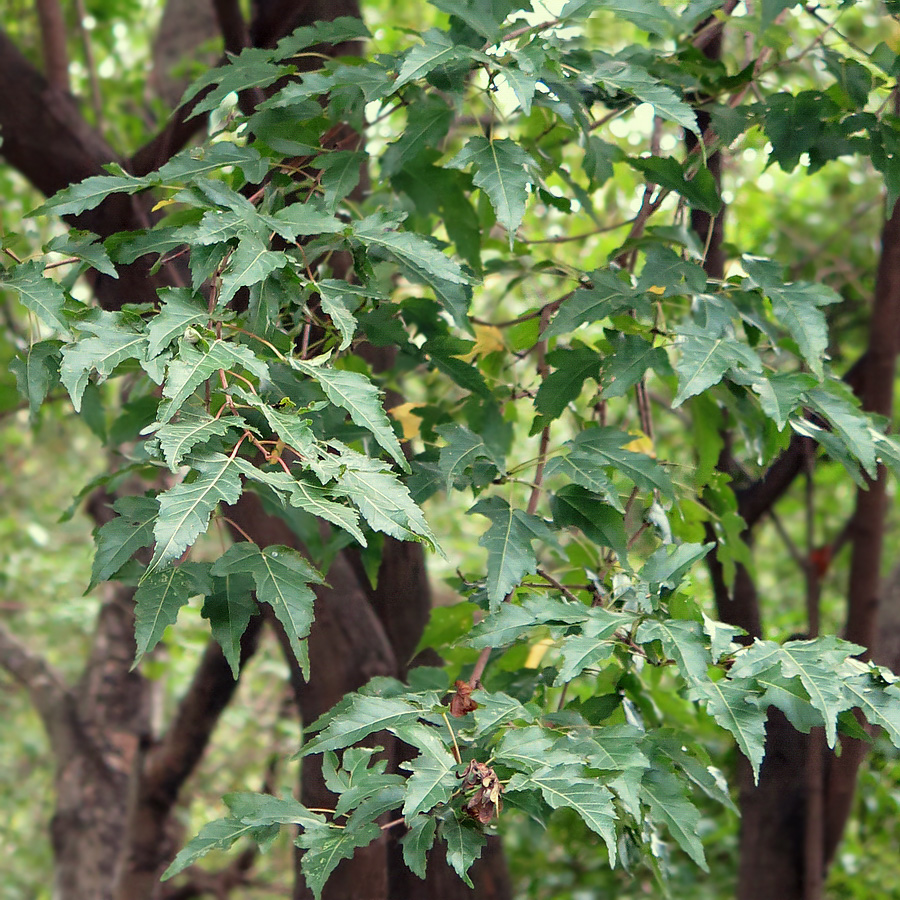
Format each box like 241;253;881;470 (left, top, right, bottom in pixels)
212;542;323;680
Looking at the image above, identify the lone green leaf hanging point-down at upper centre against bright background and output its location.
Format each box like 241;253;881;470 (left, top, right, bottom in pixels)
446;137;535;249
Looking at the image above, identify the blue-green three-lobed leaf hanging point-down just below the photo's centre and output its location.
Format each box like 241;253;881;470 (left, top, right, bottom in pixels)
468;497;553;607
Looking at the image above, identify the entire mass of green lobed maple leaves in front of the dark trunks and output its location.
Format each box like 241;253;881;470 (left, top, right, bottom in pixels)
0;0;900;896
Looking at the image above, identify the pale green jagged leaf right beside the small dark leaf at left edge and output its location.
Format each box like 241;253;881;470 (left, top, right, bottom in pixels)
59;310;147;412
